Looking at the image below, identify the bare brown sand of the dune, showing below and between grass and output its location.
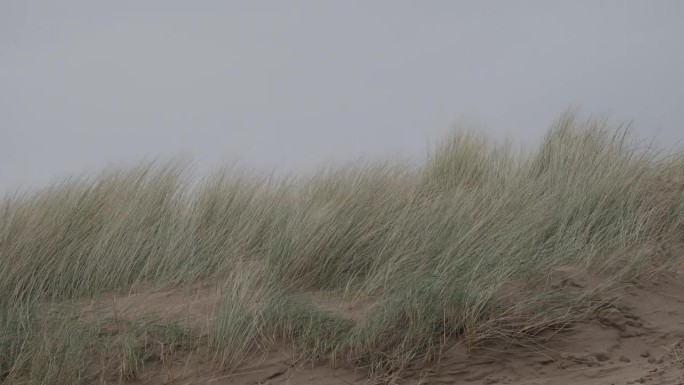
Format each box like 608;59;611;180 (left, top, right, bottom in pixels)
85;262;684;385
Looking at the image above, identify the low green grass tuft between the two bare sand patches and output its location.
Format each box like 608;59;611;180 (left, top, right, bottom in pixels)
208;263;353;370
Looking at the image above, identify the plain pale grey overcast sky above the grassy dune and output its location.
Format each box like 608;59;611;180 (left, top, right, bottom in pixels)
0;0;684;191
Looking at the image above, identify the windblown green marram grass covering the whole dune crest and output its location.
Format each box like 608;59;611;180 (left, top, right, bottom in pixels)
0;113;684;384
